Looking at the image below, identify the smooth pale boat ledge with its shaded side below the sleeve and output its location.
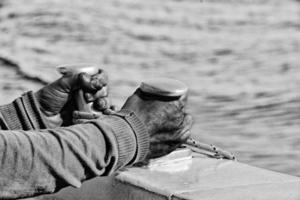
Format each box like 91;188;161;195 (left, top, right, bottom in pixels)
44;150;300;200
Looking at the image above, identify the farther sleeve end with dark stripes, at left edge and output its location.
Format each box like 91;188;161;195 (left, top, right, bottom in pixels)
0;92;47;130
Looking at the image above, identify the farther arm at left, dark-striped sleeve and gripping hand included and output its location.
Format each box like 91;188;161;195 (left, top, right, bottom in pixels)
0;66;110;130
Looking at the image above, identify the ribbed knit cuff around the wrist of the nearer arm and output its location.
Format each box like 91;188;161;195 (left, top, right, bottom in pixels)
113;110;150;165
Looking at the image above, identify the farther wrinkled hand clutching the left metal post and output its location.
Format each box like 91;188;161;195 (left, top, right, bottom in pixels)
35;70;110;128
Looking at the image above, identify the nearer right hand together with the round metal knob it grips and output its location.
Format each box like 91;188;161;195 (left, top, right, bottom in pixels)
122;78;192;160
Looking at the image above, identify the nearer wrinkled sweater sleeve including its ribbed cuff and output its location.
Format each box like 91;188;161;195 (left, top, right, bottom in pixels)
0;111;149;199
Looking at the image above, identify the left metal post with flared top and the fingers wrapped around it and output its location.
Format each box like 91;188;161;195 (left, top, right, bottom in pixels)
57;63;115;123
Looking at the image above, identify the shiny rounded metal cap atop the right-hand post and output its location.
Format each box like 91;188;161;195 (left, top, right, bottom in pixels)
140;78;188;97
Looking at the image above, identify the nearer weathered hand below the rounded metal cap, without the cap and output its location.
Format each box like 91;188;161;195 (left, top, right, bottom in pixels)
122;89;192;159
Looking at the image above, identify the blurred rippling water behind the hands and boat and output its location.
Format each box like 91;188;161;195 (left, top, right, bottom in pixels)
0;0;300;176
